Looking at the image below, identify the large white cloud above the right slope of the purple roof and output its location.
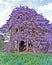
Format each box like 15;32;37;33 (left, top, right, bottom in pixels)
37;3;52;23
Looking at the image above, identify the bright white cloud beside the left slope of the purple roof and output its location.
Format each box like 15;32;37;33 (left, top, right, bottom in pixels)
0;9;11;27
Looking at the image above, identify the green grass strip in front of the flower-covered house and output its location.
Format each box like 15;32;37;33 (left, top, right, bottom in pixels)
0;52;52;65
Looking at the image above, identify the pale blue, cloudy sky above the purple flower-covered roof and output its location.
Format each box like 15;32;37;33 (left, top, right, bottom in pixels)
0;0;52;27
